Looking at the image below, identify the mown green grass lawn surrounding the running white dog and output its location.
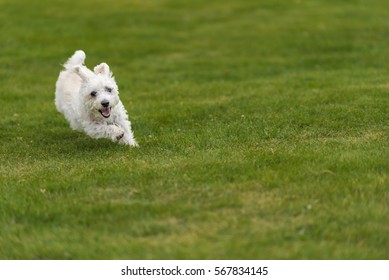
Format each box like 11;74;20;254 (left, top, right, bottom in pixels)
0;0;389;259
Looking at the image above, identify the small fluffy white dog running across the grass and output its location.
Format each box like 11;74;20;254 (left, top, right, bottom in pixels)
55;50;138;146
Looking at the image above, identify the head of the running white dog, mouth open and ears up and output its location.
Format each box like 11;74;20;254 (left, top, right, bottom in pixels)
74;63;119;118
